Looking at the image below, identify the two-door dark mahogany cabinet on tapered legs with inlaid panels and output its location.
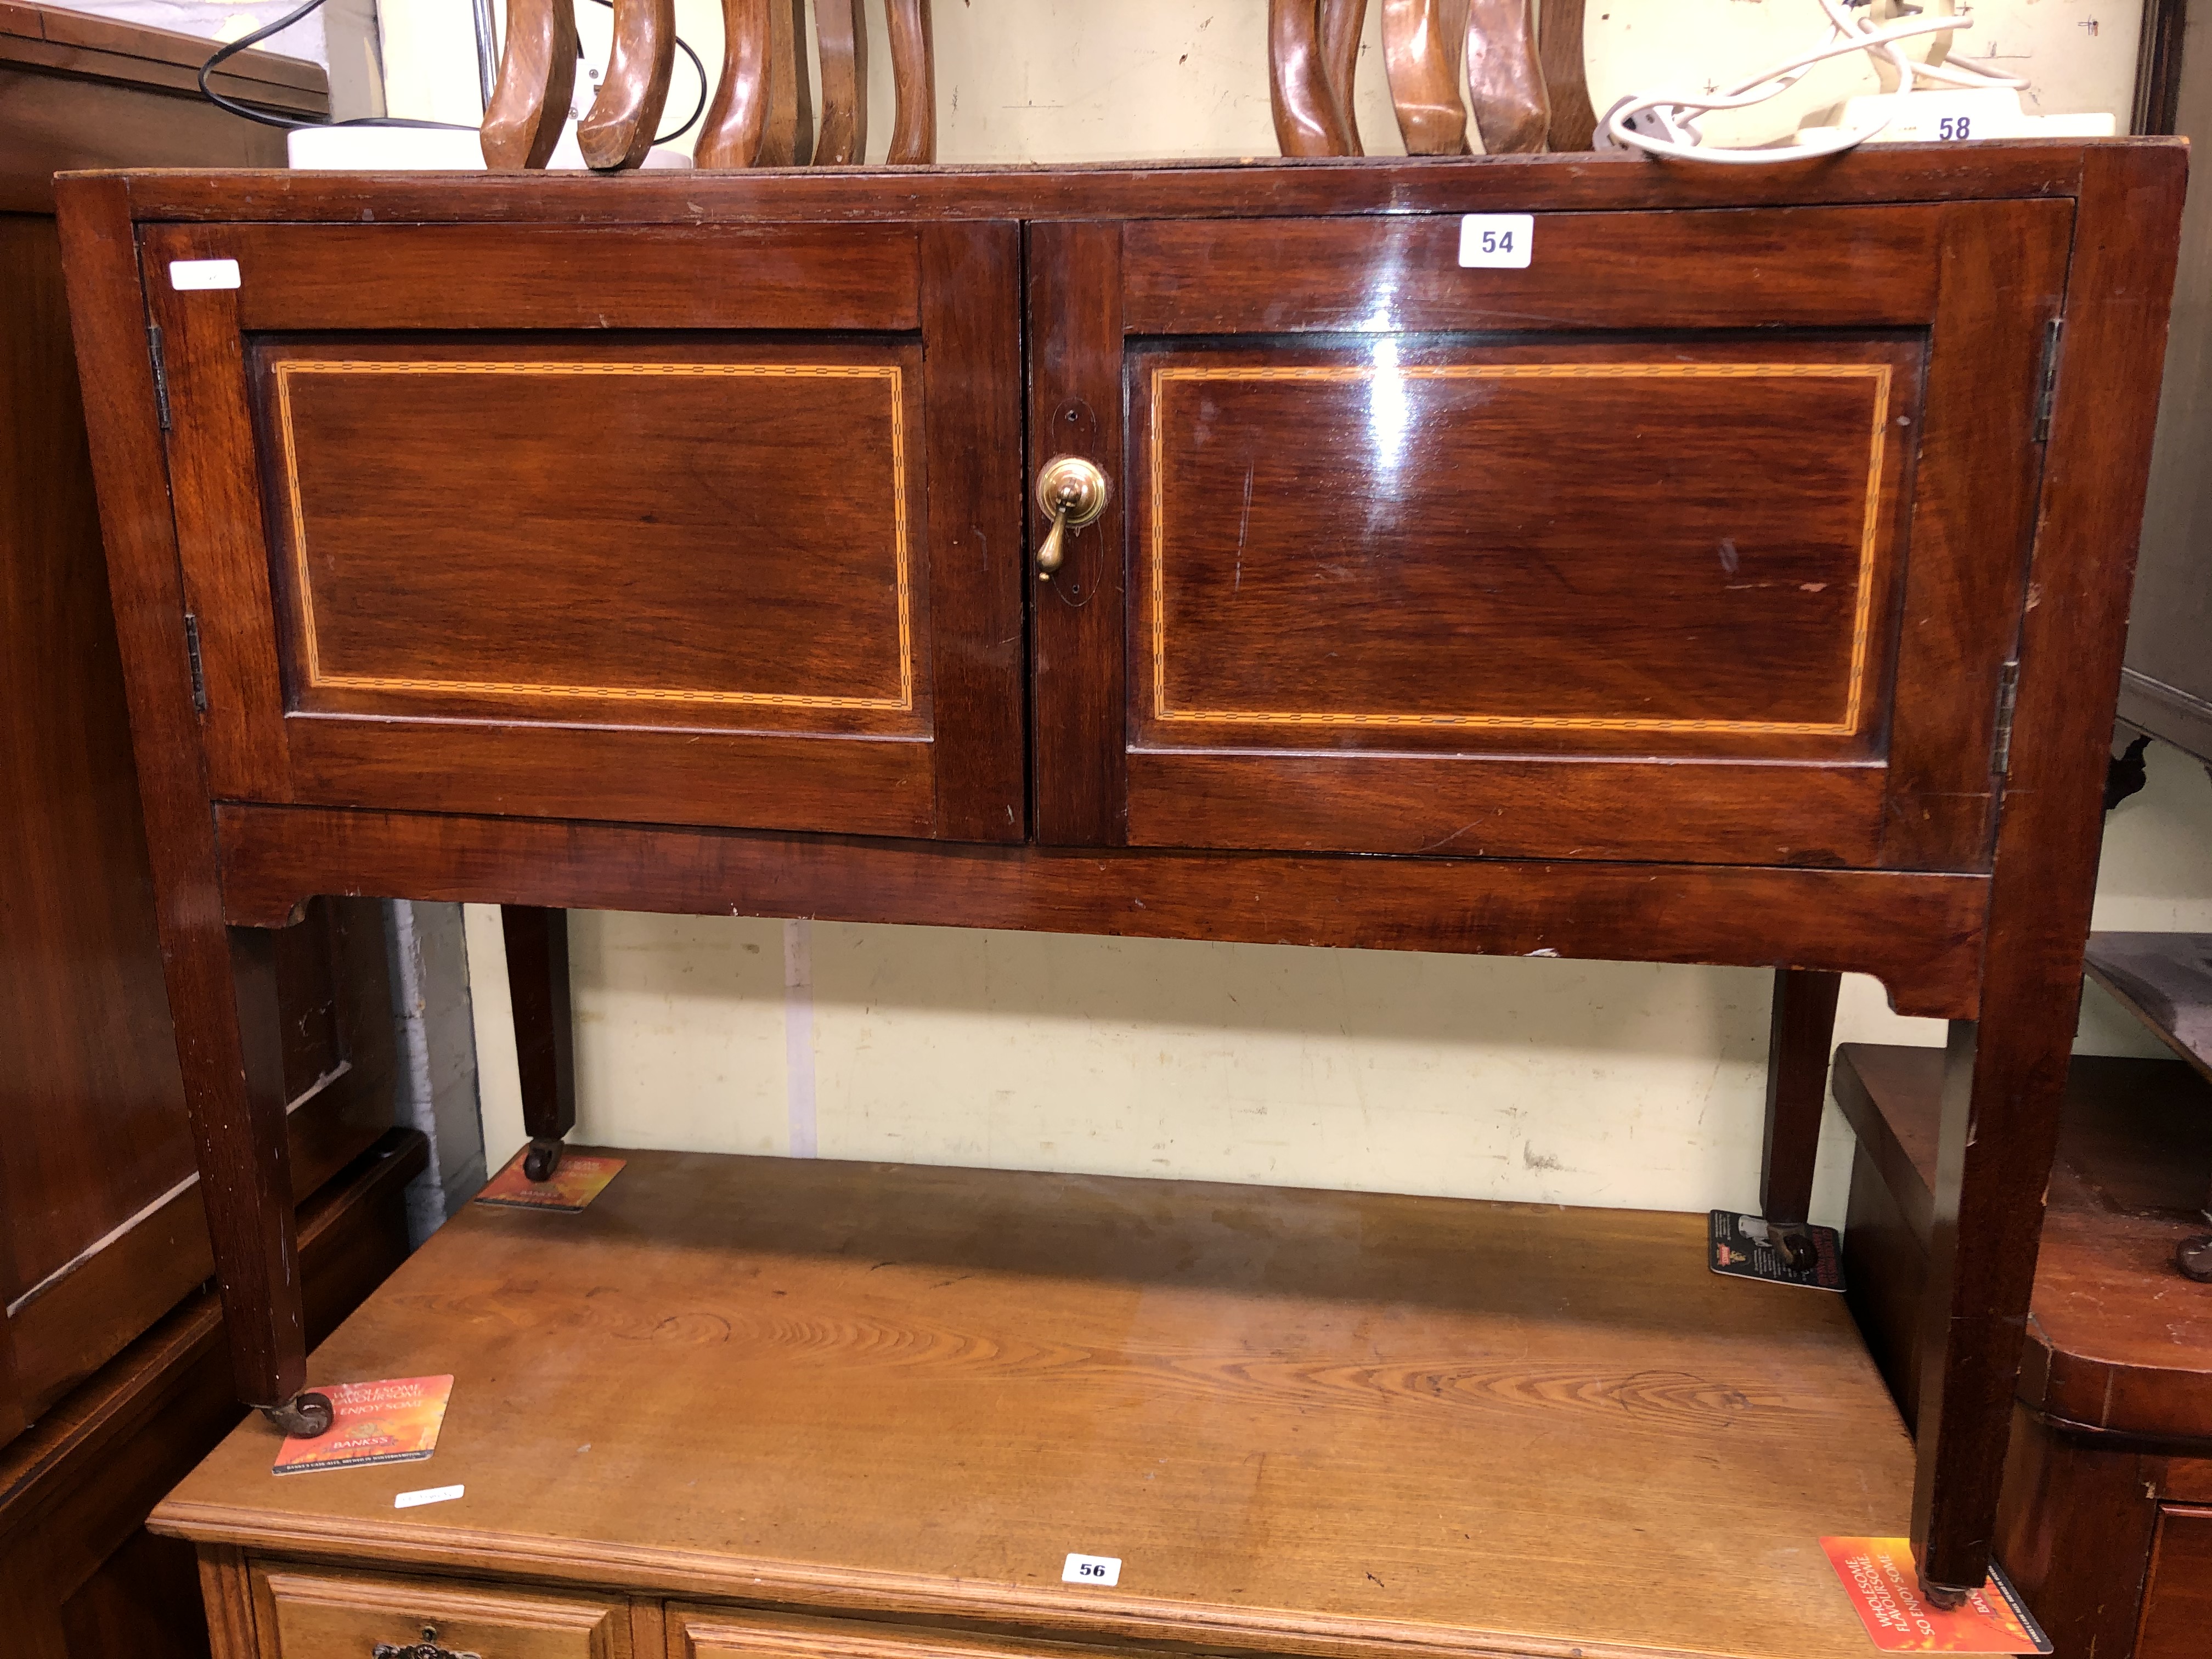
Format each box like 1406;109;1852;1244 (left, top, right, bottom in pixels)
62;142;2183;1593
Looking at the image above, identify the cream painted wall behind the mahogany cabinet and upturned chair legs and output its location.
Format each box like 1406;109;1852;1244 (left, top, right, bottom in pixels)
358;0;2212;1219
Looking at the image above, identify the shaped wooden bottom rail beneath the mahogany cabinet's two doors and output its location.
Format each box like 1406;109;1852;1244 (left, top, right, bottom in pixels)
217;805;1987;1018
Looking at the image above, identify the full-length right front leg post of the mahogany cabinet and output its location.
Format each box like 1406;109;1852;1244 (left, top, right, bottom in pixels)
1911;146;2188;1586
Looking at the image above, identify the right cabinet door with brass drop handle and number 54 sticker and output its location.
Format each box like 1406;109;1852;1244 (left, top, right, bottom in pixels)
1031;201;2073;870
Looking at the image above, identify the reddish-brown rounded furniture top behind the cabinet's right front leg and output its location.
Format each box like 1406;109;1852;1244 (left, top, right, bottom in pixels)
1834;1042;2212;1440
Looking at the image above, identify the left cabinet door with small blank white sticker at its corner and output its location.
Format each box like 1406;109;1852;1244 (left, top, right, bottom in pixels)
142;223;1024;840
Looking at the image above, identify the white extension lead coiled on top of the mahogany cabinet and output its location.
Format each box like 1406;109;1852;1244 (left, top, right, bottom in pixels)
1597;0;2026;166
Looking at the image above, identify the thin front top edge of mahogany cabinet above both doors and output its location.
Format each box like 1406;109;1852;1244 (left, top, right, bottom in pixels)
64;137;2188;223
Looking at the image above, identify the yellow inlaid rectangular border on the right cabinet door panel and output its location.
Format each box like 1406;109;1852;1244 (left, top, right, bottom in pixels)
1150;363;1891;737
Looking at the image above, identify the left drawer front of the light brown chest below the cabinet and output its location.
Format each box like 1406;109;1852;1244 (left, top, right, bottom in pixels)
255;1566;630;1659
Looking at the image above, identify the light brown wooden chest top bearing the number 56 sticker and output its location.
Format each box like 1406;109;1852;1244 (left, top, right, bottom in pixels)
155;1153;1914;1659
